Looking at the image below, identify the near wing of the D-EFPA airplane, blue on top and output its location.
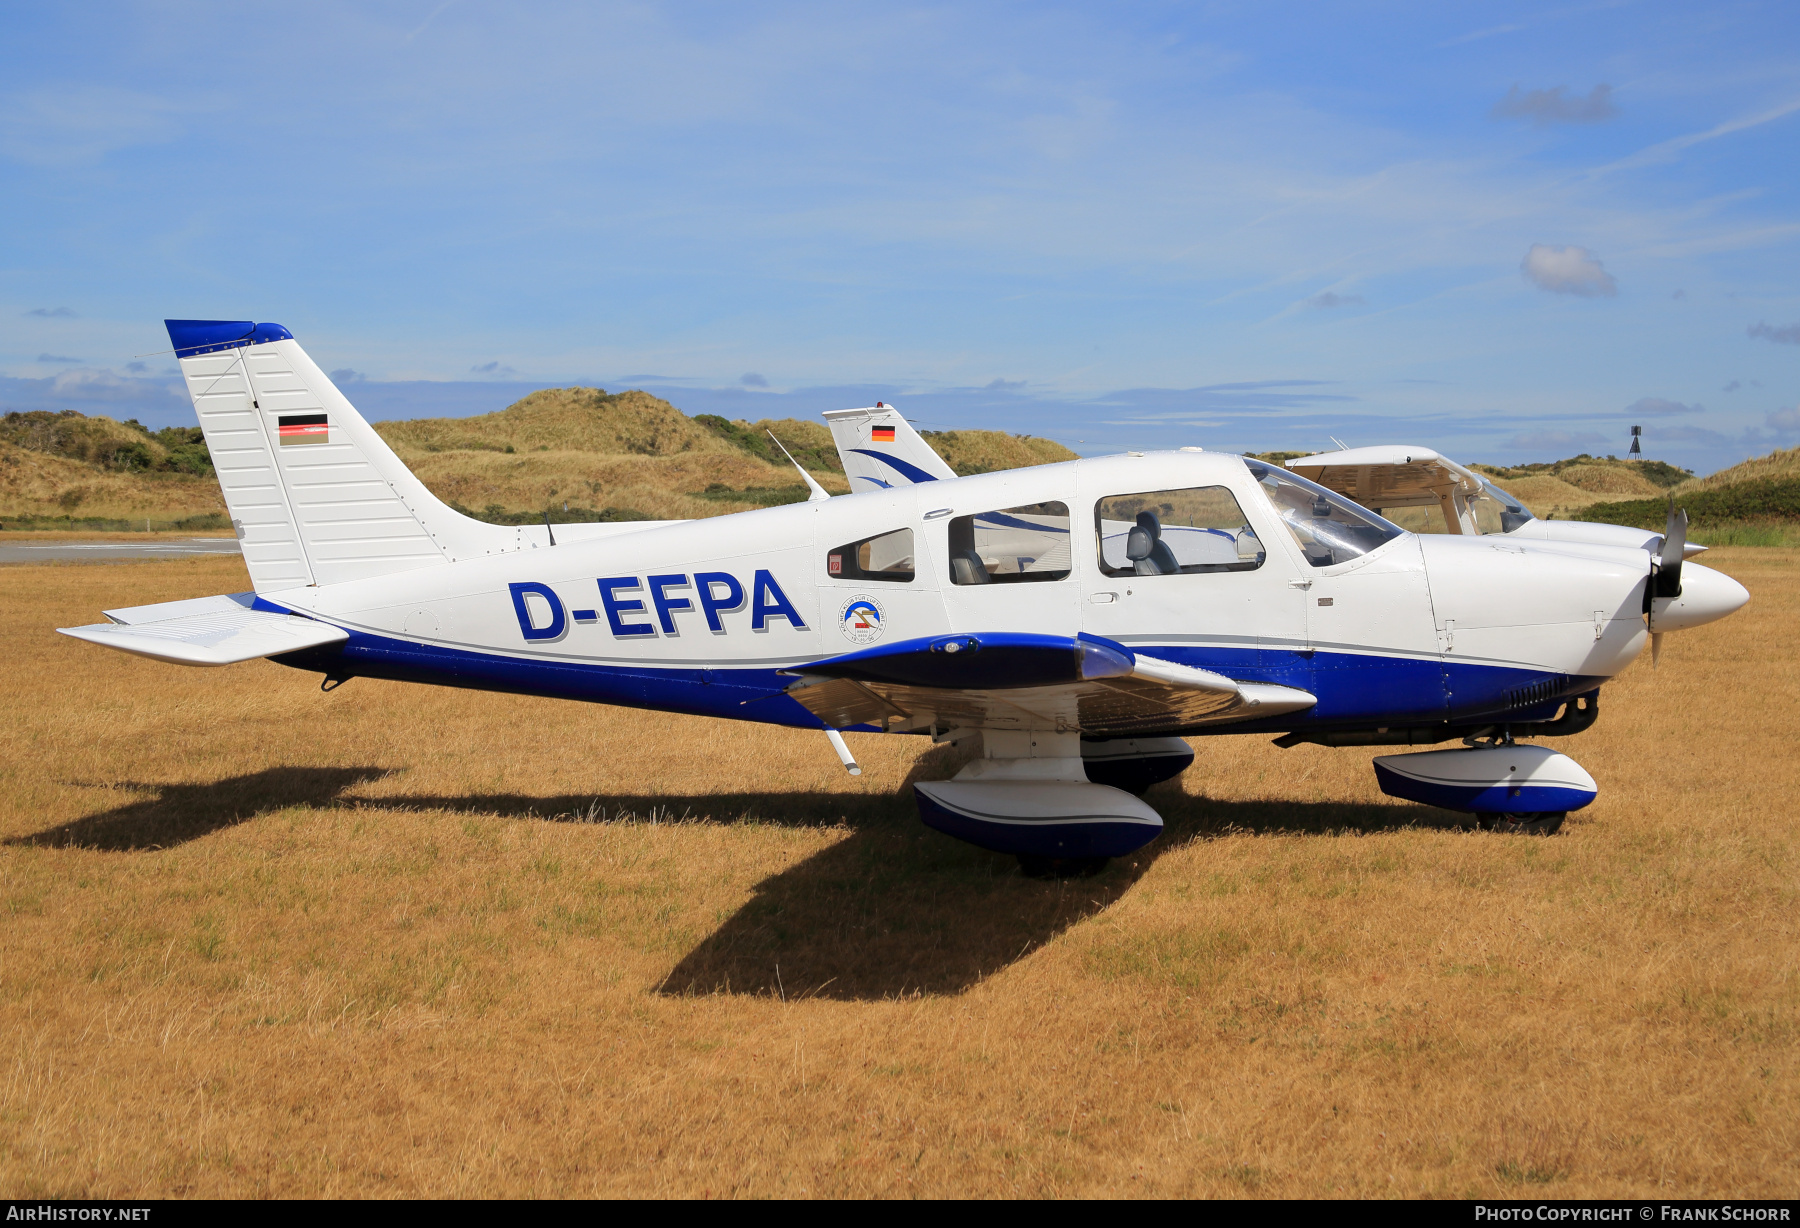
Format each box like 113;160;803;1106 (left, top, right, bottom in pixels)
788;632;1318;736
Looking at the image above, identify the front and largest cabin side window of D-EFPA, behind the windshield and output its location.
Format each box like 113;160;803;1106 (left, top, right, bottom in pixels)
1094;486;1265;576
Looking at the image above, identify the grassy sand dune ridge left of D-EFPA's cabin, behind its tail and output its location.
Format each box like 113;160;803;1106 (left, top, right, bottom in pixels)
0;387;1073;524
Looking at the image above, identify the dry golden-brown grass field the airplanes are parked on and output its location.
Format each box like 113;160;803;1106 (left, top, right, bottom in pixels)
0;549;1800;1197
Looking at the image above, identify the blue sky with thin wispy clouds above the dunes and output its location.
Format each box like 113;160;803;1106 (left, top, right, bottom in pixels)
0;0;1800;472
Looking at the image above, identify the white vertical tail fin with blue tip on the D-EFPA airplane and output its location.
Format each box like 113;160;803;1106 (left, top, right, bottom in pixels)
166;321;525;592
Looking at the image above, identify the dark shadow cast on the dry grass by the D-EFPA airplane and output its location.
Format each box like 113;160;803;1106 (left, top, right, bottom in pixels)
9;753;1456;1001
